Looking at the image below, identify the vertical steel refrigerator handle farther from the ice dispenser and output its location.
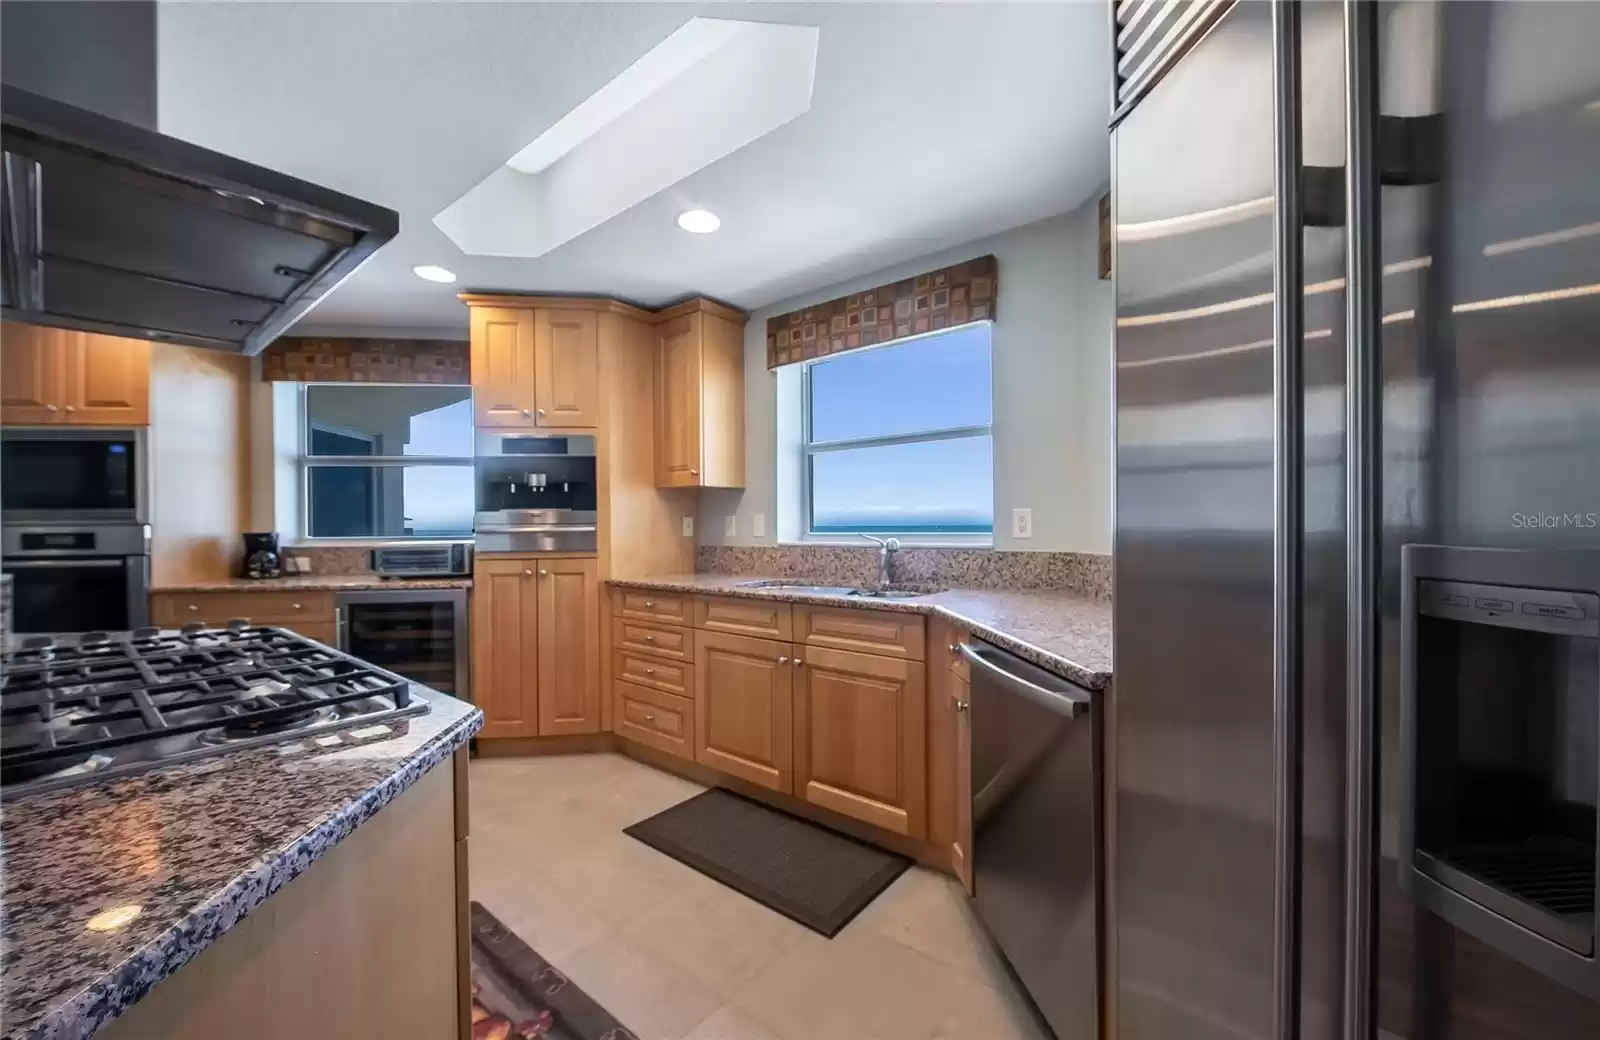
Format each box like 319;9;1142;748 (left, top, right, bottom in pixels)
1272;3;1299;1040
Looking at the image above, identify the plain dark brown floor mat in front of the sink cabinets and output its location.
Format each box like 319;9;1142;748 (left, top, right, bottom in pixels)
624;787;910;938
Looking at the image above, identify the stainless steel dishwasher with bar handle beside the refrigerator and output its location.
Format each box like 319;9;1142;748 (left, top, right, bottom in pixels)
962;640;1101;1040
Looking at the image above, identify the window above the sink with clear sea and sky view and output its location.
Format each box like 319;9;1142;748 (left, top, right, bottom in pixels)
803;322;995;538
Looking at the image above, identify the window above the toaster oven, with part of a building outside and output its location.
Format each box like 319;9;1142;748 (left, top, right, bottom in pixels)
301;382;477;538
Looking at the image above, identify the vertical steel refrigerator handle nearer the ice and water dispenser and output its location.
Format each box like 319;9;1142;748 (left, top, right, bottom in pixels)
1342;0;1382;1040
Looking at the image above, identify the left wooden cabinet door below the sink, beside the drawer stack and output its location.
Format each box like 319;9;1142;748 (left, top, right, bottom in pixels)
694;632;797;794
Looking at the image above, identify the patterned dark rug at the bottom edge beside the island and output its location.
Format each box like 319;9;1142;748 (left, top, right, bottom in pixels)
472;902;638;1040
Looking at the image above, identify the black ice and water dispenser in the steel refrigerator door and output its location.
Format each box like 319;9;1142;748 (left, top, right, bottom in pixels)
1400;546;1600;995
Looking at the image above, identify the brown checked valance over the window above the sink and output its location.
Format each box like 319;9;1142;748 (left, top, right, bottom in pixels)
766;256;1000;368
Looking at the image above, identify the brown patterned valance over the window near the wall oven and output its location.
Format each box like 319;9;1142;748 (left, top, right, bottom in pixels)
261;336;472;386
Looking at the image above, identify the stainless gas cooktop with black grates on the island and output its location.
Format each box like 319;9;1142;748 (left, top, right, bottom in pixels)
0;621;429;797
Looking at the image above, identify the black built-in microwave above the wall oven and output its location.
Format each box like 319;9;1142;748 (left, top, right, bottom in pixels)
0;427;149;523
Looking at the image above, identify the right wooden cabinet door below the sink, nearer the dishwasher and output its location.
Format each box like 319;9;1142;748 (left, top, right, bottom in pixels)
794;645;928;838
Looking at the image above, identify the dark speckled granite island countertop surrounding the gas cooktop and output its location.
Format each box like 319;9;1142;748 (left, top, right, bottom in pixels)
0;686;483;1040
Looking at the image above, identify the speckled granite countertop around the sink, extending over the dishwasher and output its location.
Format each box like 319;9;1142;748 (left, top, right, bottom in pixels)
611;574;1110;690
